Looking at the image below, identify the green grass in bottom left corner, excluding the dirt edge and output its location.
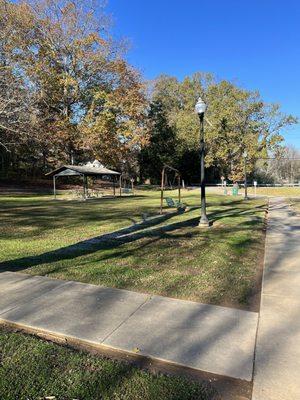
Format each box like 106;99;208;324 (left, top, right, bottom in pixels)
0;329;219;400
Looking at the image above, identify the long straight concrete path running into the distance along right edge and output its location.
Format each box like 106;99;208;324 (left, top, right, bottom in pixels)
252;199;300;400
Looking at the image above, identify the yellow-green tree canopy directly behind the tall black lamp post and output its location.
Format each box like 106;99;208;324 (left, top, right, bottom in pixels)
142;73;296;181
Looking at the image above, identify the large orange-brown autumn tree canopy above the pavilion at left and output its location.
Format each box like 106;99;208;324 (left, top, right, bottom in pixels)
0;0;146;176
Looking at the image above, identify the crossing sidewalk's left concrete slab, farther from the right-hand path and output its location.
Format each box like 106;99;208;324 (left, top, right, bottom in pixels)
0;280;148;343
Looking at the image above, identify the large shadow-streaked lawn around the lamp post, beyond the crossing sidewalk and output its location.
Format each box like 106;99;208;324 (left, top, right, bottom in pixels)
0;190;266;308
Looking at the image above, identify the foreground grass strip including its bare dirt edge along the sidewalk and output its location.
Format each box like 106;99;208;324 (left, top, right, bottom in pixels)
0;323;252;400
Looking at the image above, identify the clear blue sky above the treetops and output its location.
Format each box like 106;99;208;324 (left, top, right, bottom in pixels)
108;0;300;149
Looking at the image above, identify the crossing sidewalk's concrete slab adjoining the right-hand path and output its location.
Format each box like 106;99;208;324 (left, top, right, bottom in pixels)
104;296;258;381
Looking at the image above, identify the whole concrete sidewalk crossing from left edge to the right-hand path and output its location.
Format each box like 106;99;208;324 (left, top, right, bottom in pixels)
0;272;258;381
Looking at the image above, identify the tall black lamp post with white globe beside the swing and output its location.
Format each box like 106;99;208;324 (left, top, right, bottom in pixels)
195;97;209;227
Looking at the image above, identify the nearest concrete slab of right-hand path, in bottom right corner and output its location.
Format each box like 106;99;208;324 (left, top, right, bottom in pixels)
252;296;300;400
